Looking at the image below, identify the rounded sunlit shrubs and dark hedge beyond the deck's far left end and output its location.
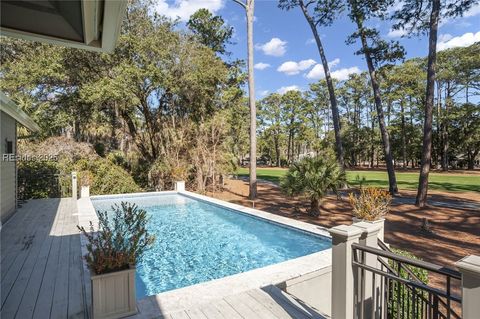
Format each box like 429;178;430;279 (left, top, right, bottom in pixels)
18;137;141;199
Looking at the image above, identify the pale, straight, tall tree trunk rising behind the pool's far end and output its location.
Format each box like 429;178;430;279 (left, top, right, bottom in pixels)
233;0;257;199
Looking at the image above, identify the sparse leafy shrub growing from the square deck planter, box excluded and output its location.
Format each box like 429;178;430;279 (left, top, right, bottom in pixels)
77;202;155;275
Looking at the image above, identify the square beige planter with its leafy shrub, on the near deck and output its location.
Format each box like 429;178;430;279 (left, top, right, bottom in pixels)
77;202;155;319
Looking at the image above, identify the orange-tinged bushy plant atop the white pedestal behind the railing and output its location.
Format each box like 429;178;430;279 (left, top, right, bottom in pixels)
349;187;392;221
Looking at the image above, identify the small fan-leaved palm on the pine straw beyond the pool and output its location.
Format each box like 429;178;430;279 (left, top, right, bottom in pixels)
280;155;346;217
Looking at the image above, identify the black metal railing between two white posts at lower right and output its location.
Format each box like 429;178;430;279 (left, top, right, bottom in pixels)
352;241;462;319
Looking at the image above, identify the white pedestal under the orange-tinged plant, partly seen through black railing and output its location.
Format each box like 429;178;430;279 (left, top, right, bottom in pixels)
352;222;383;318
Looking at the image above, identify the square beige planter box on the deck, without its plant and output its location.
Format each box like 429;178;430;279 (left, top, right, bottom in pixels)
91;267;137;319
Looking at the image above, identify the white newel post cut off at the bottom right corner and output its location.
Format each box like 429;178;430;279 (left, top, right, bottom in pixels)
455;255;480;319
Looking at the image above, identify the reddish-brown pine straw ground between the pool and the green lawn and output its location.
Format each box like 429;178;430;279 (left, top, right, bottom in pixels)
203;179;480;296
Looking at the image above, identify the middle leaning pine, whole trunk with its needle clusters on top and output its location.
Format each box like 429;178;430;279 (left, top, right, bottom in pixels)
347;0;404;195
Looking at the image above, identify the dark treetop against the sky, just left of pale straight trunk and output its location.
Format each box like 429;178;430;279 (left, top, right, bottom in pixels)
187;8;233;54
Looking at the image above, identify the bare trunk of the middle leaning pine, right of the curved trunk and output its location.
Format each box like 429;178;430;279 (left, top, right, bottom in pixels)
356;17;398;195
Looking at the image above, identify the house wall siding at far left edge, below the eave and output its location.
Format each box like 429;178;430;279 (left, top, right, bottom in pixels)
0;112;17;224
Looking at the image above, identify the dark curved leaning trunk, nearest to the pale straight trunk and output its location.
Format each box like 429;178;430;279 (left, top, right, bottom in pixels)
299;0;345;169
